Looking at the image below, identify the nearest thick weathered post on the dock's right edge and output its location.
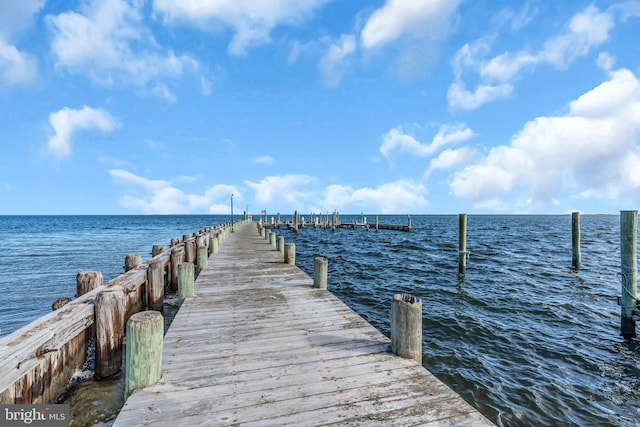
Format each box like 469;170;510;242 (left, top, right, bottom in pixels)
391;294;422;364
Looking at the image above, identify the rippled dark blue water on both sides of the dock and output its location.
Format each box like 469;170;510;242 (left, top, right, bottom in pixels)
0;215;640;426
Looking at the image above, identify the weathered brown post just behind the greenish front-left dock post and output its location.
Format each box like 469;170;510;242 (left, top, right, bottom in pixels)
95;286;126;379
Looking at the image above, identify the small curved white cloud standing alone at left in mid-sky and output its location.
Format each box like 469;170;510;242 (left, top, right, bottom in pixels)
47;106;118;159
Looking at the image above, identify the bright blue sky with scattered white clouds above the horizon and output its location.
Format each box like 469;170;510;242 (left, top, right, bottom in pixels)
0;0;640;214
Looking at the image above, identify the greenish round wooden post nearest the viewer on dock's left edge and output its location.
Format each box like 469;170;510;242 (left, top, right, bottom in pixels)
124;311;164;399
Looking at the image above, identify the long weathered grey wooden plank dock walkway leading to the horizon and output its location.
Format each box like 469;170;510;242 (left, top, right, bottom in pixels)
114;224;493;427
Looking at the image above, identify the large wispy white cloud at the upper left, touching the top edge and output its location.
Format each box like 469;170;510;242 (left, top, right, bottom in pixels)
47;0;199;93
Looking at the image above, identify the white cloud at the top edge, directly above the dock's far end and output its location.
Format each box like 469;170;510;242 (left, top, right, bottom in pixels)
153;0;328;55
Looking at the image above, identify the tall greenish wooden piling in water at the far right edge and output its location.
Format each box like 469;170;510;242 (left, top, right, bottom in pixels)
620;210;638;339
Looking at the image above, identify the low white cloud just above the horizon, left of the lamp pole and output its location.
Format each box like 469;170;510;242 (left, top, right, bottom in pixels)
109;169;243;214
